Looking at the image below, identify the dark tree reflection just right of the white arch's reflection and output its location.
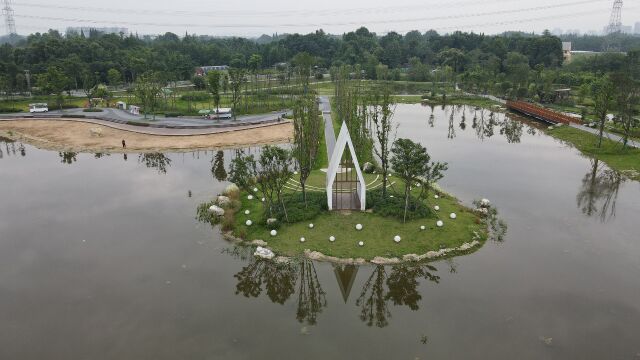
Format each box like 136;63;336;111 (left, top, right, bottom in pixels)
356;264;440;327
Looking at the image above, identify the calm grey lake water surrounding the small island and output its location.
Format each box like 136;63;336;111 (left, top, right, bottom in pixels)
0;105;640;360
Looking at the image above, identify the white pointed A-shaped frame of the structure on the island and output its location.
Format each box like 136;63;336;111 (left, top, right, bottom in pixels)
327;122;367;211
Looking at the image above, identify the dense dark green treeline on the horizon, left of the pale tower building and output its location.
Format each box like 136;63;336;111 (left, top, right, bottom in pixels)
0;27;636;90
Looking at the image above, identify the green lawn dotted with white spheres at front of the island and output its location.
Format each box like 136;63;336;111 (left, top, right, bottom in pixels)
234;172;486;260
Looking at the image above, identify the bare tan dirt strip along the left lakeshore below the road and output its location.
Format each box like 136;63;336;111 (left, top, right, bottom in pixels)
0;119;293;152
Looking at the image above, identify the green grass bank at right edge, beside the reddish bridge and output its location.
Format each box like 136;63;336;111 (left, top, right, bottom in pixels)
547;126;640;180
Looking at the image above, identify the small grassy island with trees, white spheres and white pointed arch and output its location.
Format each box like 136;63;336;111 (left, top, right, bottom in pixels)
198;79;505;264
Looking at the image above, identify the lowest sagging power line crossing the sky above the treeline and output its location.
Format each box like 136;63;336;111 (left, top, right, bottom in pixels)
10;0;602;29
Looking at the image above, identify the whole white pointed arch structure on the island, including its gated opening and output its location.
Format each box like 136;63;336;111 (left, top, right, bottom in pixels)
327;123;367;211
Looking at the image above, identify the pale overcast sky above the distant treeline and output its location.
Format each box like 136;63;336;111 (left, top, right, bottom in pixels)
6;0;640;36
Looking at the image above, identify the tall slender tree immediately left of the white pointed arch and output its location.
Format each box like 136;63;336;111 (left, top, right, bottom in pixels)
293;95;323;206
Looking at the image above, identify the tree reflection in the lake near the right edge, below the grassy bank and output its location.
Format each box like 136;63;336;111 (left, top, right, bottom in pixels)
576;159;626;222
